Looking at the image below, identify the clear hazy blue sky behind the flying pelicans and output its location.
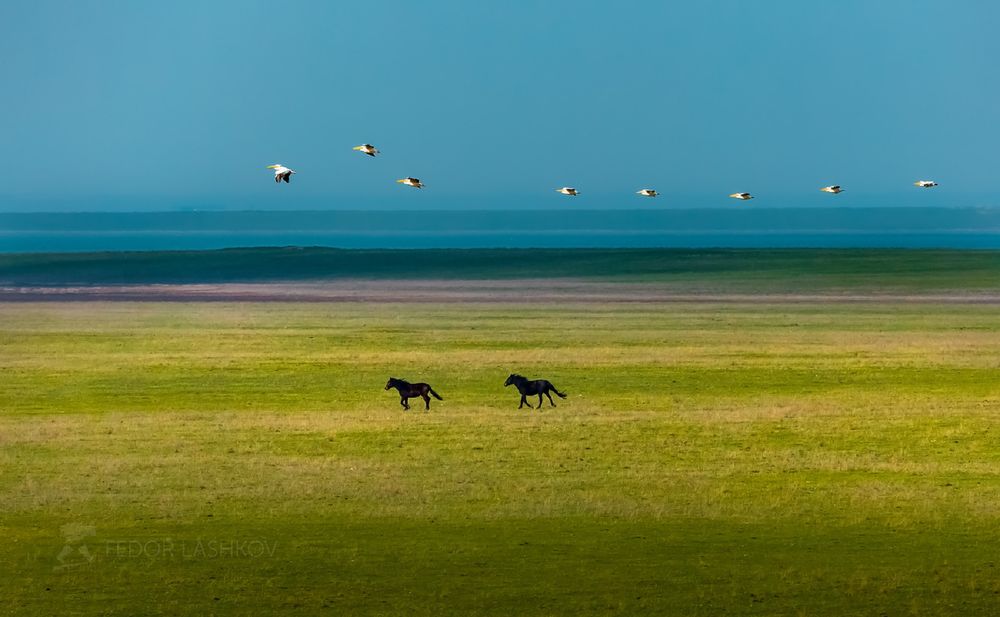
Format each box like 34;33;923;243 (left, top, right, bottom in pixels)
0;0;1000;211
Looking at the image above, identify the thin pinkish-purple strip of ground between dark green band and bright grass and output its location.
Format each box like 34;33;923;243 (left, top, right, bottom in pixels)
0;279;1000;304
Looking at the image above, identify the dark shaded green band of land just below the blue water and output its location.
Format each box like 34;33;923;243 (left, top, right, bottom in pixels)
0;247;1000;300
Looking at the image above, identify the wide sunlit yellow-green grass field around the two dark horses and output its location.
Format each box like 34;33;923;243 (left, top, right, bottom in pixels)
0;248;1000;616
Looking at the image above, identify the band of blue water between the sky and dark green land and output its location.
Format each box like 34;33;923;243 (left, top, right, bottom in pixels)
0;208;1000;253
